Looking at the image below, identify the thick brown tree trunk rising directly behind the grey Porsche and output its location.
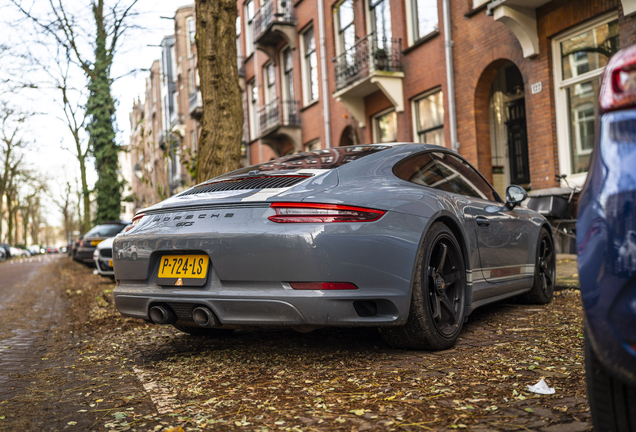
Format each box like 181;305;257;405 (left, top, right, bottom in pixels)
195;0;243;182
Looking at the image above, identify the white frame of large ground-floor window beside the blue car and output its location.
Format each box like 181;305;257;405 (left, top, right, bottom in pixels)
552;11;618;187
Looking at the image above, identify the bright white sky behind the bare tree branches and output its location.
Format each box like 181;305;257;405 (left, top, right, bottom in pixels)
0;0;193;230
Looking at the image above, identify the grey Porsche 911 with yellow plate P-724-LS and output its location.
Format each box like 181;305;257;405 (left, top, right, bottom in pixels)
113;144;555;349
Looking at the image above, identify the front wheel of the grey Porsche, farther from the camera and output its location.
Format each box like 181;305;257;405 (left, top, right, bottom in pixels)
519;228;556;304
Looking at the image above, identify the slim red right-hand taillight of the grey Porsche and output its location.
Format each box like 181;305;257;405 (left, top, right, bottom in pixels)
269;203;386;223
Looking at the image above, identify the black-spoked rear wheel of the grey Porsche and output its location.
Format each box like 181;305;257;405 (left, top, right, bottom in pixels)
379;222;466;350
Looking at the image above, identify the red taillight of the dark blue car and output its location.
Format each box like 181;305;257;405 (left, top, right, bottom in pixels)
599;47;636;112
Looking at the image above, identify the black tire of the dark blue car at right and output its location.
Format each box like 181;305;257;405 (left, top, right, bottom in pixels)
585;332;636;432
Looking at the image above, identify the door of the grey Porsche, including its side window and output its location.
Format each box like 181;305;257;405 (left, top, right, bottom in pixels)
433;152;534;283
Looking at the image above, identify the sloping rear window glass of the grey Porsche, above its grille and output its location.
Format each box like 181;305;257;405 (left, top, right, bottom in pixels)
219;146;391;178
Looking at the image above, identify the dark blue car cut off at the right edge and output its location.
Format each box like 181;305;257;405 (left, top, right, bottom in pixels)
577;45;636;431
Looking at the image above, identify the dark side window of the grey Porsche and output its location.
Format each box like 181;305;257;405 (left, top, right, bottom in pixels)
432;152;500;202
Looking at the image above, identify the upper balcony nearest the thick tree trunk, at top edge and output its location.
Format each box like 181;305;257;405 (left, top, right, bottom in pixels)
254;0;296;61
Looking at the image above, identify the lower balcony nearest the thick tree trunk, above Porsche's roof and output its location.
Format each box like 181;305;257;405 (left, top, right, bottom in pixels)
258;98;302;153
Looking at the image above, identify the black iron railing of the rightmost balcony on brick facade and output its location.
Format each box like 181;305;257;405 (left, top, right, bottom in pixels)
332;33;402;90
